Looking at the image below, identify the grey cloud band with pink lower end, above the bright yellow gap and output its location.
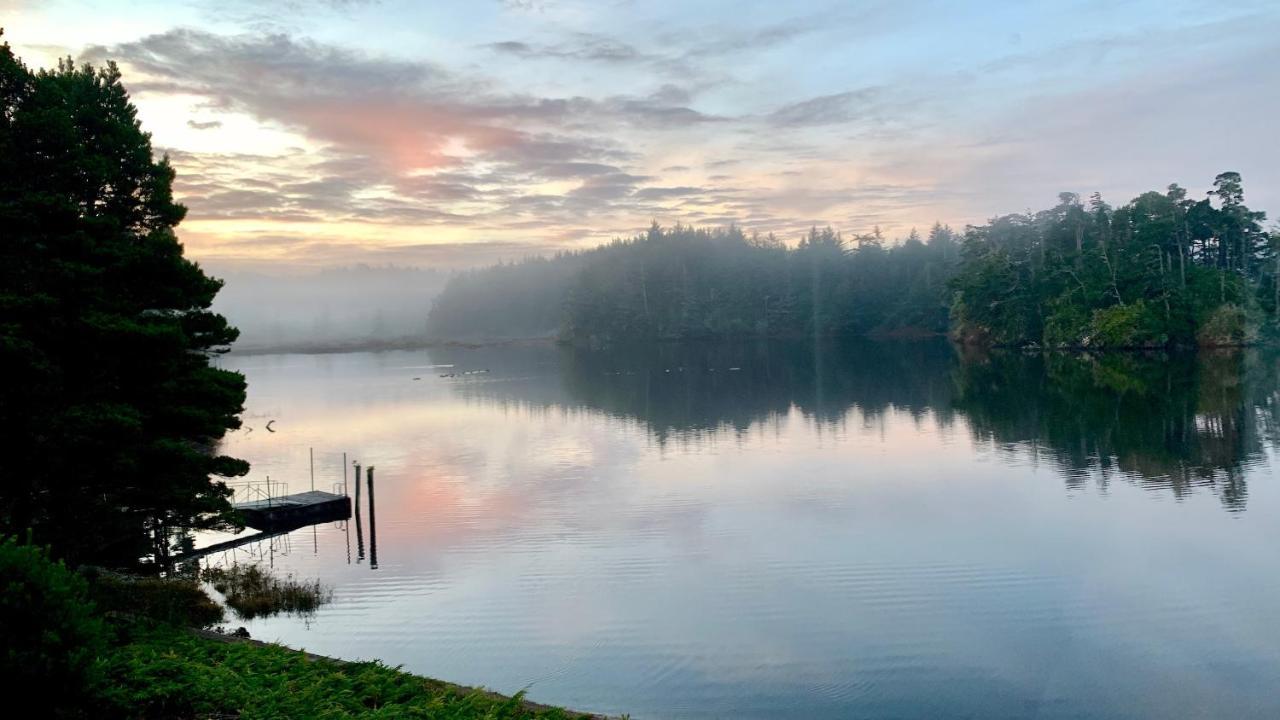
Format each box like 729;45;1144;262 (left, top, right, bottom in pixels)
84;29;494;169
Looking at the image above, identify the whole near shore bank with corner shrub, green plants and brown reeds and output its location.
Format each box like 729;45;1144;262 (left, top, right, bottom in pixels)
0;538;606;720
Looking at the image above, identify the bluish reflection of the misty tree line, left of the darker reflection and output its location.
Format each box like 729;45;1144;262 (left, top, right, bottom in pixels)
433;342;955;442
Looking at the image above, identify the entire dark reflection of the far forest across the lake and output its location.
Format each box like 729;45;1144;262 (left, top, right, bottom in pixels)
433;341;1280;511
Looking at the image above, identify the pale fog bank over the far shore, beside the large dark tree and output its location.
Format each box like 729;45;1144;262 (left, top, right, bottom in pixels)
214;265;448;352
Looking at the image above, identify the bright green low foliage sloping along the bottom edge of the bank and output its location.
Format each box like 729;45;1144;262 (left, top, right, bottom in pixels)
104;624;591;720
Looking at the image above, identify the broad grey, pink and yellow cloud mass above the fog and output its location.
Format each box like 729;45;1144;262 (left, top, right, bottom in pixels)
83;29;747;253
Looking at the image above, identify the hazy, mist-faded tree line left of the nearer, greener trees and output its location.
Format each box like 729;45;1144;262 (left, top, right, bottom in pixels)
428;223;960;343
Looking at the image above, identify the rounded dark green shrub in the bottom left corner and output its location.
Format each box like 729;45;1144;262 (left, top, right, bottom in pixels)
0;538;108;715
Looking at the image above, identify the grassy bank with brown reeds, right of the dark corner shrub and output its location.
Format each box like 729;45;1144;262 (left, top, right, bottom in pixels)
87;565;604;720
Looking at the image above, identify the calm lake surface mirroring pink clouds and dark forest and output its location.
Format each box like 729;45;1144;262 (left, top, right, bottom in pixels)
211;343;1280;719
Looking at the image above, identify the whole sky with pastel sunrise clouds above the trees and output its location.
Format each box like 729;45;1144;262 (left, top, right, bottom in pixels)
0;0;1280;272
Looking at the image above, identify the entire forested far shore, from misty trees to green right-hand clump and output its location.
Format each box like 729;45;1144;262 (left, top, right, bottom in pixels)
429;178;1280;348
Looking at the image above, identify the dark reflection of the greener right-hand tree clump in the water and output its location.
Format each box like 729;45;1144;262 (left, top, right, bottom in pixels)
955;352;1271;511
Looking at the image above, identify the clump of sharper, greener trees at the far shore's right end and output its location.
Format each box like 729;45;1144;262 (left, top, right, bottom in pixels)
952;173;1280;347
